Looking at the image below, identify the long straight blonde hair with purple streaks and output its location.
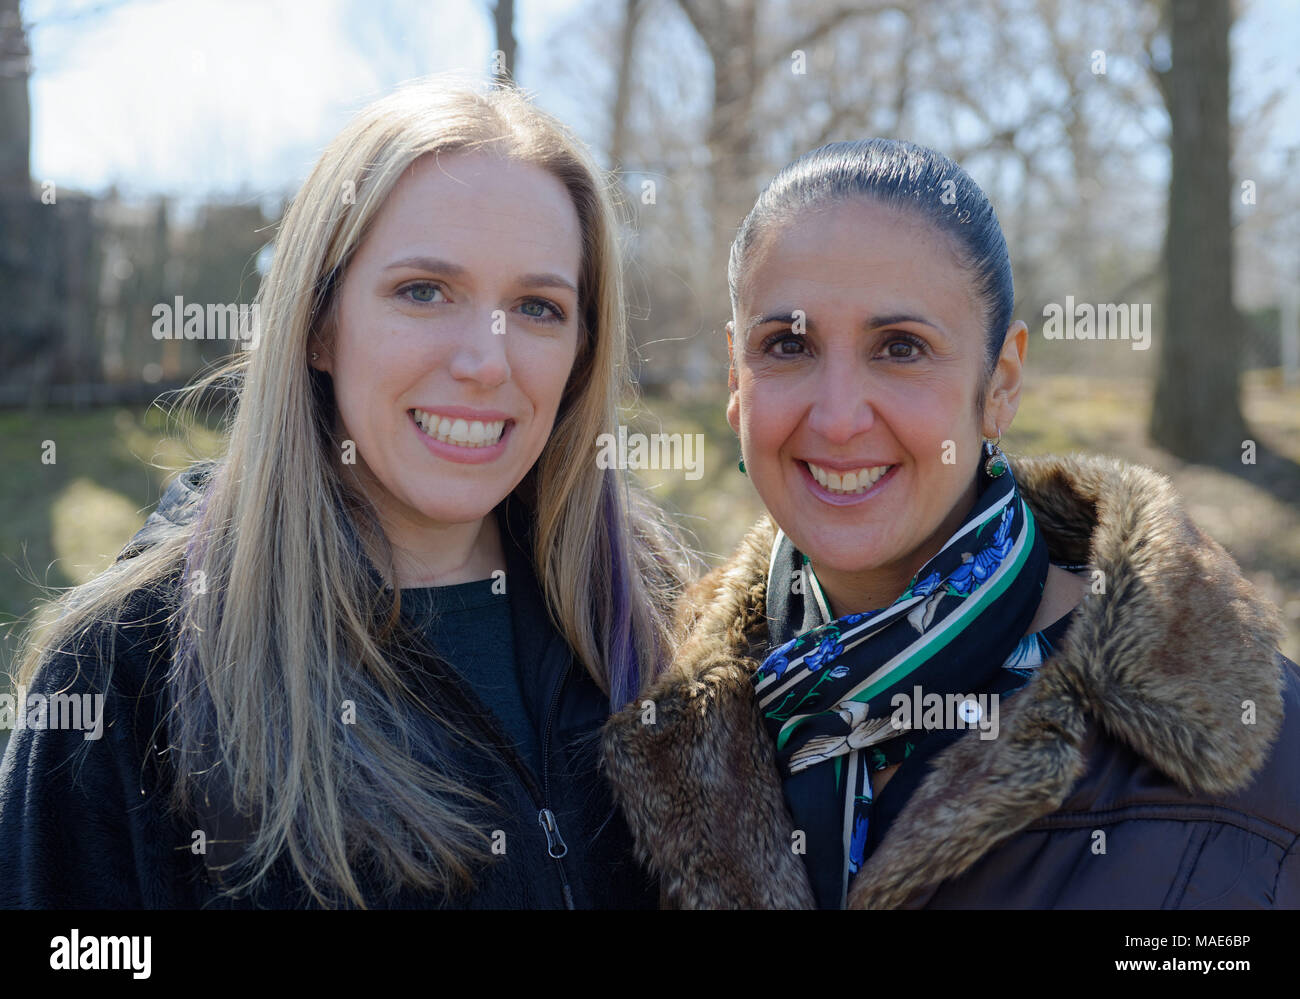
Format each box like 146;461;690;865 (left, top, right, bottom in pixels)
20;79;694;907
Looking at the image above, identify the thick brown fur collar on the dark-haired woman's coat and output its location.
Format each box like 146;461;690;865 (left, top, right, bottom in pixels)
605;455;1283;908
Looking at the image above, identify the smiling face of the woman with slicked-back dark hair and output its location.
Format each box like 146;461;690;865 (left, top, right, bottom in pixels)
727;198;1027;614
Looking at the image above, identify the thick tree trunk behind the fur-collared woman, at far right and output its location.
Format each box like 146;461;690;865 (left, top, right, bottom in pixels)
1151;0;1249;463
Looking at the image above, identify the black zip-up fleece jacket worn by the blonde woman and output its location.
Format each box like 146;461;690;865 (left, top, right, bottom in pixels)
0;467;657;908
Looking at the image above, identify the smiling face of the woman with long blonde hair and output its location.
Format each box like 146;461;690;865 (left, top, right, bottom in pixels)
312;152;581;542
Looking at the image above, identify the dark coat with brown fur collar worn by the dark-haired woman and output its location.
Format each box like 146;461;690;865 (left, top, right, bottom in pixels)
605;455;1300;909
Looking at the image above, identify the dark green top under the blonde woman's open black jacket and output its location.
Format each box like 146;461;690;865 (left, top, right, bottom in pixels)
402;579;542;780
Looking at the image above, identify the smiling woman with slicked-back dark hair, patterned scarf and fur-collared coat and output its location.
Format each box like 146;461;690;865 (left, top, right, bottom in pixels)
606;139;1300;908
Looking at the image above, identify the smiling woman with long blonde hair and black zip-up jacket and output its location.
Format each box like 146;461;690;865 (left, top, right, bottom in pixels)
0;82;685;908
